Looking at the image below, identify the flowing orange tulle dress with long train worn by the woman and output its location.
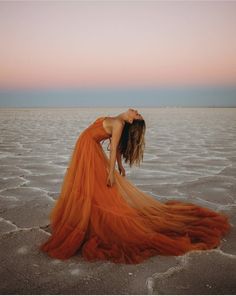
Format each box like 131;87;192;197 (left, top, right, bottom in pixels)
39;117;231;264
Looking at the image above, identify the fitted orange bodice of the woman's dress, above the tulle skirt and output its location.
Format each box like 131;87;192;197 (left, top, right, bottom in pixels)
83;116;111;142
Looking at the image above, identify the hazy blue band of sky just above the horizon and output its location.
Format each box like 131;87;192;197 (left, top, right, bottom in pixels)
0;86;236;107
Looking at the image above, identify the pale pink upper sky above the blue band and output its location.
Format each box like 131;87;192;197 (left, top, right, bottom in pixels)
0;1;236;88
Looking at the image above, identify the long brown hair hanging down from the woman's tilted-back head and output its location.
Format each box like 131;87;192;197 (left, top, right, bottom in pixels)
107;119;146;167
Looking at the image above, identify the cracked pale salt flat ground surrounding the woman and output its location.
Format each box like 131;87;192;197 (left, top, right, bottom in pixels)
0;108;236;295
